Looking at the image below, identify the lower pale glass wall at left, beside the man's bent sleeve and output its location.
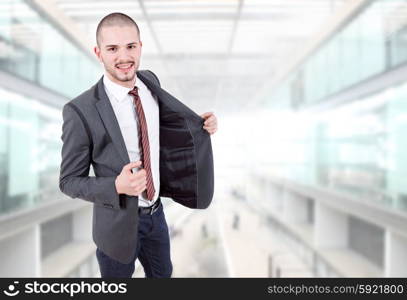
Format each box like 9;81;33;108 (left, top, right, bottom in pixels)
0;89;62;214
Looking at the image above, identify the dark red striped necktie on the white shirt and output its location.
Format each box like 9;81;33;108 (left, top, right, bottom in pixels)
129;86;155;200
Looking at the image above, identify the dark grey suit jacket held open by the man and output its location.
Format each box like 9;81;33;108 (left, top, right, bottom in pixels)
59;70;214;263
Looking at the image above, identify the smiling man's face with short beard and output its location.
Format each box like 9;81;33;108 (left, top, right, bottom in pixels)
94;26;142;88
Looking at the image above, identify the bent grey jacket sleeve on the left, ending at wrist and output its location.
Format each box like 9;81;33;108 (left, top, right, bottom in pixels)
59;103;120;209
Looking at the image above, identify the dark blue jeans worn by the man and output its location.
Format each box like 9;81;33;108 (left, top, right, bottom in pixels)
96;203;172;278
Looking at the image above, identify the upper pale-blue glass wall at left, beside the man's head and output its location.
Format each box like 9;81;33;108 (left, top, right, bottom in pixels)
0;0;101;98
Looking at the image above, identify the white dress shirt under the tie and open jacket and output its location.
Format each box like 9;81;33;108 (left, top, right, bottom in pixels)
103;74;160;207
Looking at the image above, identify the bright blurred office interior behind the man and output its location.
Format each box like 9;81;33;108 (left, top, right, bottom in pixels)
0;0;407;277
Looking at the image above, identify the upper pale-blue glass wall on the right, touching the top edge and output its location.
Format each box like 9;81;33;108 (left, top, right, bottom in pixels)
262;0;407;109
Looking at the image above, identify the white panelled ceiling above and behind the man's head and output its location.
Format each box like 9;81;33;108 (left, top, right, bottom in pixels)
55;0;352;113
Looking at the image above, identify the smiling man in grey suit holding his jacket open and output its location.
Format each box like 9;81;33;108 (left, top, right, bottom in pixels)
59;13;217;278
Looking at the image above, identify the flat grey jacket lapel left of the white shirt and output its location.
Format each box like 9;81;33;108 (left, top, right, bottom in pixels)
95;77;130;164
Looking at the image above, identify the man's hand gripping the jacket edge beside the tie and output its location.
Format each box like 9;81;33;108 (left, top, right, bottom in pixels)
115;161;147;196
